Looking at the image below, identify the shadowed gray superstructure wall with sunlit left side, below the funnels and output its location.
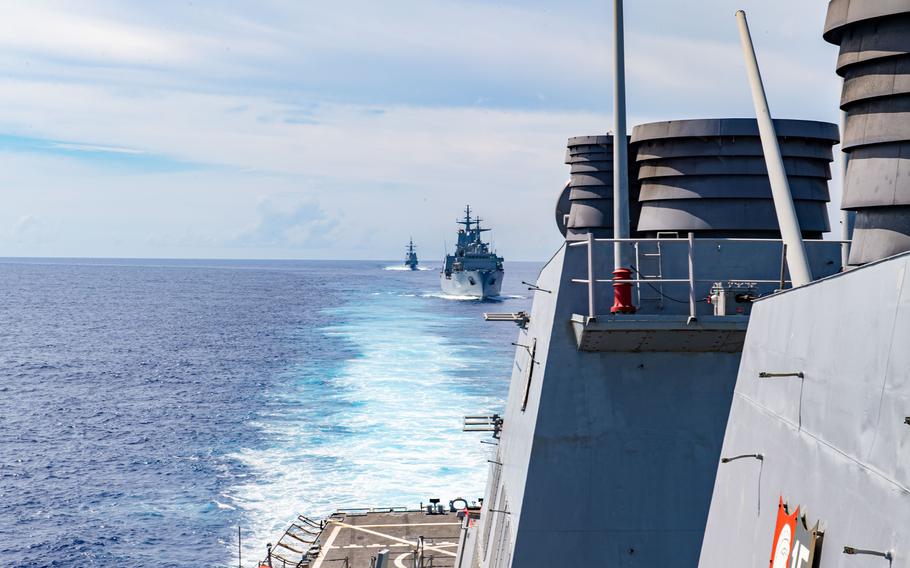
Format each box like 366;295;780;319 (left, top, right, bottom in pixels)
473;239;840;568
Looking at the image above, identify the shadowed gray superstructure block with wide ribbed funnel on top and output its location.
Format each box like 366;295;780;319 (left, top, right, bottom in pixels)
463;119;841;568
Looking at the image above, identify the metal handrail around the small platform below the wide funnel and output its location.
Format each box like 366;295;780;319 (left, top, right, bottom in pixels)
566;232;851;323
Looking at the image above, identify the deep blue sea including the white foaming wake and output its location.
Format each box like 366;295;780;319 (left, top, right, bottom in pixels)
0;259;539;567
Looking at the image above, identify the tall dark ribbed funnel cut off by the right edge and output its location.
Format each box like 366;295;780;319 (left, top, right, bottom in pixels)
824;0;910;265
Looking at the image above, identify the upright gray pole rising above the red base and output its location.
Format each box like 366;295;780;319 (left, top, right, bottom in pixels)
613;0;629;269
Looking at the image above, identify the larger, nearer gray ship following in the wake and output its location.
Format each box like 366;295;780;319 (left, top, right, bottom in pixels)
439;205;504;298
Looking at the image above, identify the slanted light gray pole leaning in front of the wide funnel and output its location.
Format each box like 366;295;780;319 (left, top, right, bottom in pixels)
736;10;812;288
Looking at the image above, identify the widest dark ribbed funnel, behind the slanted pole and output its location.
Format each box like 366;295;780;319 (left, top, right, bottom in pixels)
632;118;838;238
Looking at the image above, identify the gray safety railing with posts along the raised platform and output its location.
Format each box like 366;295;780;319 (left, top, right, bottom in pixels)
568;233;850;322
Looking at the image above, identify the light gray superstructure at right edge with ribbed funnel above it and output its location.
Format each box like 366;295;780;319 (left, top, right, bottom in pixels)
699;0;910;568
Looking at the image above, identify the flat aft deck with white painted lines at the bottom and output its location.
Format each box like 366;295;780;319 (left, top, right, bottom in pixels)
312;511;462;568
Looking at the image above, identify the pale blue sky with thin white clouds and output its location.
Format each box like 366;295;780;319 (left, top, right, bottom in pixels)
0;0;840;260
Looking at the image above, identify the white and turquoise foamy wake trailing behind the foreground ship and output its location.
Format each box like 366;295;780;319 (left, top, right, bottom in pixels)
230;294;508;558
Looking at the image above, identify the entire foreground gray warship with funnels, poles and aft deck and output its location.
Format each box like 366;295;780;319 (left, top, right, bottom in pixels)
258;0;910;568
